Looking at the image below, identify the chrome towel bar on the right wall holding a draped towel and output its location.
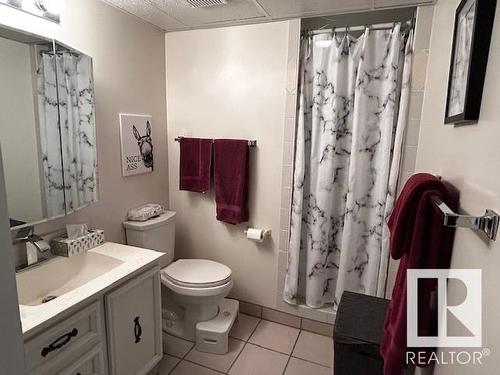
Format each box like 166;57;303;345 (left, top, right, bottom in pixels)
434;197;500;241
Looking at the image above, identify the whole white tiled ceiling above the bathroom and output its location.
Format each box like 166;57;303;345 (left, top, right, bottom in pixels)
103;0;434;32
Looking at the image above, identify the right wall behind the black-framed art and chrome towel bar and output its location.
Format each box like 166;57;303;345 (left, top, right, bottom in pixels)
416;0;500;375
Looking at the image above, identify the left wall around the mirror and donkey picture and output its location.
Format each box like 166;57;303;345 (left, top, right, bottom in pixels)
0;0;168;247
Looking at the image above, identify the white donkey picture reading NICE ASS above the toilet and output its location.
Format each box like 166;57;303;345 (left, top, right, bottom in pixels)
120;113;154;177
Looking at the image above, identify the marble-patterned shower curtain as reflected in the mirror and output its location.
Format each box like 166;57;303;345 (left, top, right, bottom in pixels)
38;51;97;217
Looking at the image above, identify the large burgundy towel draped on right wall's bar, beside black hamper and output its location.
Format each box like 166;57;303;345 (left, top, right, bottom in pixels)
380;173;458;375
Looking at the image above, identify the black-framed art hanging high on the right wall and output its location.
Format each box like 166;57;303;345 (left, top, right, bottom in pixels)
444;0;496;124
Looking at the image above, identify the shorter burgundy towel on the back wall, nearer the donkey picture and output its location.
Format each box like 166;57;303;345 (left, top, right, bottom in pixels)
179;137;213;193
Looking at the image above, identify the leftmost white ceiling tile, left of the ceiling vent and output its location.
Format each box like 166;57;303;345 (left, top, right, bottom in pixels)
104;0;186;31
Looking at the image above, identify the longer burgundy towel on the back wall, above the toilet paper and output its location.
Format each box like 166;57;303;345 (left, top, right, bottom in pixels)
214;139;248;224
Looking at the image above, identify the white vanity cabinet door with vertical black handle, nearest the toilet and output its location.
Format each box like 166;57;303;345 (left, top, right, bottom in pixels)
105;267;163;375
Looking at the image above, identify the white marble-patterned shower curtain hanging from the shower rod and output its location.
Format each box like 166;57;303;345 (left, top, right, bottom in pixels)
283;24;413;308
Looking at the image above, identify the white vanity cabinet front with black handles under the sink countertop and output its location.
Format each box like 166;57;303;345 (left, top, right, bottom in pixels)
24;266;163;375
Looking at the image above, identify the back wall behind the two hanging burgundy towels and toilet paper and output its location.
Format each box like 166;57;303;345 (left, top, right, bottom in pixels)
166;22;289;307
